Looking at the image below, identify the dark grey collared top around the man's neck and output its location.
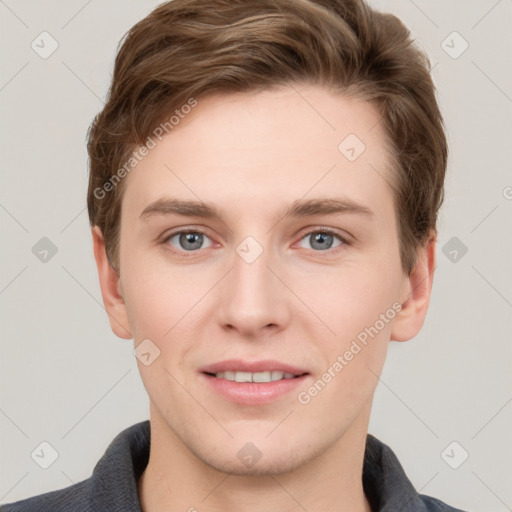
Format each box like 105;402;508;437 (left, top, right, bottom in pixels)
0;420;463;512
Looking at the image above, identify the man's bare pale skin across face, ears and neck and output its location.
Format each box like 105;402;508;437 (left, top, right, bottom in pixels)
92;84;435;512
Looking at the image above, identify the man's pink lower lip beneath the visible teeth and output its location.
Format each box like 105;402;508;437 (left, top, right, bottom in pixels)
201;373;309;405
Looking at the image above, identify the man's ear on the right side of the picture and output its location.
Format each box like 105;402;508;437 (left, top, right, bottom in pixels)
391;233;437;341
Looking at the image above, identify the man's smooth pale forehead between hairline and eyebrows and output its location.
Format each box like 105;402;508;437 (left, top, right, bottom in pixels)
123;85;392;222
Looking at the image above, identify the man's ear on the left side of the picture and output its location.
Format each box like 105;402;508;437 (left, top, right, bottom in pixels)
91;226;133;340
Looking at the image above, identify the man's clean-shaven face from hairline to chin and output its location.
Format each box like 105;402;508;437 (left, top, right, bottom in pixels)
93;85;432;474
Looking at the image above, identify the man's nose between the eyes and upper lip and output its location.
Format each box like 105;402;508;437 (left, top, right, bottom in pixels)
216;241;291;338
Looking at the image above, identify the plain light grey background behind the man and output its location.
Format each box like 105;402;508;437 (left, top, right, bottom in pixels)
0;0;512;512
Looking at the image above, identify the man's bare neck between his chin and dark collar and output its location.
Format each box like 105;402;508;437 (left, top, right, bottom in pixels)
138;409;371;512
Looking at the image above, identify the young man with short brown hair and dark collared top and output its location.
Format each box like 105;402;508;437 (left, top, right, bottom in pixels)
3;0;470;512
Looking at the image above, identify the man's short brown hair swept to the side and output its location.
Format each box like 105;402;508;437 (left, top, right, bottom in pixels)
87;0;448;274
